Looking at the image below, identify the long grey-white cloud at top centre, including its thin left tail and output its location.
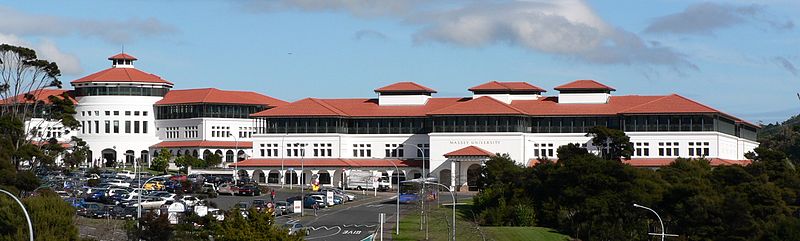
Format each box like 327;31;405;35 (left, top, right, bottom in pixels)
243;0;697;70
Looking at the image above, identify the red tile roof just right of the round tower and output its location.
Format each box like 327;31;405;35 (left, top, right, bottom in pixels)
156;88;287;107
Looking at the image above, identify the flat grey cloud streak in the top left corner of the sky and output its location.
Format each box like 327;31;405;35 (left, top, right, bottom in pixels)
0;6;176;44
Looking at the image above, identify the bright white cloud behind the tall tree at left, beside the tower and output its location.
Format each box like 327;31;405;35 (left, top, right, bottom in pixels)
0;33;83;75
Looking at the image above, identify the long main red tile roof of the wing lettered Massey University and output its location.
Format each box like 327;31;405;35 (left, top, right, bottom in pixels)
251;87;758;128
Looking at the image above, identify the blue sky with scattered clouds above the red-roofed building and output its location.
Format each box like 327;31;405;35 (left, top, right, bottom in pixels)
0;0;800;124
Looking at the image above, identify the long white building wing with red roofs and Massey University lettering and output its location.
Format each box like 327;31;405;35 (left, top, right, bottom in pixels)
245;80;759;191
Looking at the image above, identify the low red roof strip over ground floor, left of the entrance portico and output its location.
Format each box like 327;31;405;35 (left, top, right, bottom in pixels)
232;158;422;168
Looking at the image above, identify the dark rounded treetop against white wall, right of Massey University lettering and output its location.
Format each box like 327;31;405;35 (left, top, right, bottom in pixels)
586;126;633;160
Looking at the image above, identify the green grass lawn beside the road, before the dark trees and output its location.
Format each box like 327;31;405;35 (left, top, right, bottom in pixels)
393;202;569;241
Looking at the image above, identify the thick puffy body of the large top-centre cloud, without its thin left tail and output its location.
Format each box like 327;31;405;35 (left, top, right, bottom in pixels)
413;0;697;70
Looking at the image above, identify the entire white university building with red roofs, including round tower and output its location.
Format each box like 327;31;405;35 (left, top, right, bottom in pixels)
6;53;759;191
